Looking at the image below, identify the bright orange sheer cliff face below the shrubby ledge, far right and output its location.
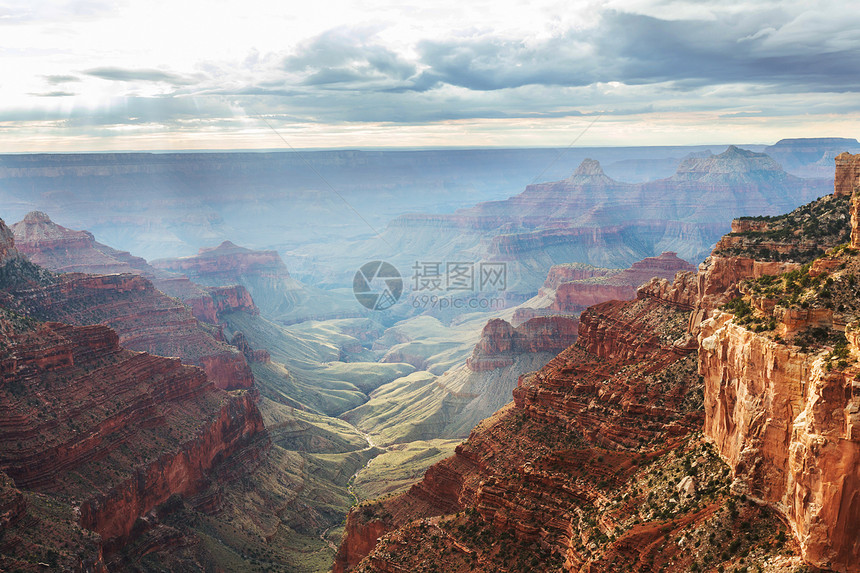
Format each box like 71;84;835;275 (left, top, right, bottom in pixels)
699;313;860;571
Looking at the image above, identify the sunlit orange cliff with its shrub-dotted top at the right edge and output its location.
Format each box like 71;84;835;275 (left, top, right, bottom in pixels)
699;150;860;571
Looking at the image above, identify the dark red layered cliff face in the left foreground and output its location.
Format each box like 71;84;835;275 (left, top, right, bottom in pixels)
0;315;268;552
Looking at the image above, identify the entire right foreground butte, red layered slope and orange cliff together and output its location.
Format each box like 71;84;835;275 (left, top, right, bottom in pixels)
334;154;860;573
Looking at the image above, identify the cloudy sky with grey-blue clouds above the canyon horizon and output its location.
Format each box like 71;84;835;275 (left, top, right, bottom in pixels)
0;0;860;152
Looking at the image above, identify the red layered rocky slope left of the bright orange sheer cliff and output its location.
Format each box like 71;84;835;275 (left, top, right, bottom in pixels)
335;274;796;571
